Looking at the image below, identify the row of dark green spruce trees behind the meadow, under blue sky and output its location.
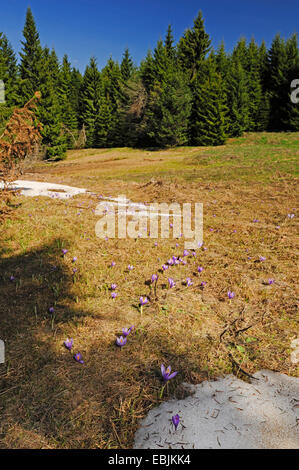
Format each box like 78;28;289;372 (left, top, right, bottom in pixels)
0;8;299;159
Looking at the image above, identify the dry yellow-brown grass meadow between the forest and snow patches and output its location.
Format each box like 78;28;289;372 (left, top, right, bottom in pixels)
0;133;299;448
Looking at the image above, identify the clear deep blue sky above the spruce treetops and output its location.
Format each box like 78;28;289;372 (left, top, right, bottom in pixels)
0;0;299;72
